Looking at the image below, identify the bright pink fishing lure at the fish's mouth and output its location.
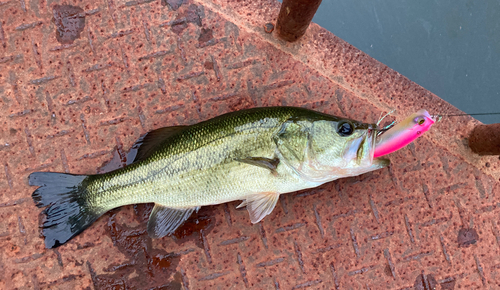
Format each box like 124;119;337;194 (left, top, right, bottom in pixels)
373;109;436;158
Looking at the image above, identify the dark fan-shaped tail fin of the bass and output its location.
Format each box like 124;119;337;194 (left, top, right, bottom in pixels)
28;172;102;248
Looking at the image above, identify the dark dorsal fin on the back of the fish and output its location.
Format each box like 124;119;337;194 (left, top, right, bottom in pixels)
127;126;188;165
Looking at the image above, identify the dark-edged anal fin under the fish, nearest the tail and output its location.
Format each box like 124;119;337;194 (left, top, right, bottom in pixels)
148;204;200;238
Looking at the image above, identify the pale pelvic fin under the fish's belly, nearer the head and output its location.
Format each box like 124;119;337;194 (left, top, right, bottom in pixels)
236;192;280;224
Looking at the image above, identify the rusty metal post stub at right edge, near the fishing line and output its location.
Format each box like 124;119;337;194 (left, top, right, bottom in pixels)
469;123;500;155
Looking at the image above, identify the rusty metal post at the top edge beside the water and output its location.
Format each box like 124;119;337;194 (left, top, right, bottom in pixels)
276;0;321;42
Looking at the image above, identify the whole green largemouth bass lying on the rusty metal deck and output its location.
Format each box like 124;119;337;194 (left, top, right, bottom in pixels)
29;107;416;248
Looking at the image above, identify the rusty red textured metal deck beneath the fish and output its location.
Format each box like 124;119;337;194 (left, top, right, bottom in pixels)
0;0;500;289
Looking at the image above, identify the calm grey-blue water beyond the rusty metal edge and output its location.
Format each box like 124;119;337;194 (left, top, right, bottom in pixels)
294;0;500;123
